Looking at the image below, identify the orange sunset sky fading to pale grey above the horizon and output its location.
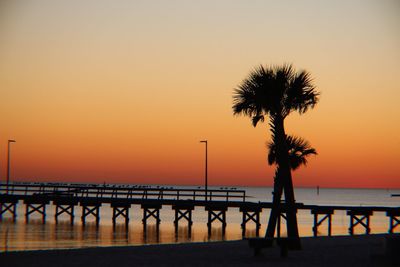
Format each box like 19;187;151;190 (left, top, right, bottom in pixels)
0;0;400;188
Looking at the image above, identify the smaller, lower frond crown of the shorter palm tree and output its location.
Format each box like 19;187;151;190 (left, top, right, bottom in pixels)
267;135;317;171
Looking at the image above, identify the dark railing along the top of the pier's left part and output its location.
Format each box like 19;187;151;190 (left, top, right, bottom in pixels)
0;182;246;202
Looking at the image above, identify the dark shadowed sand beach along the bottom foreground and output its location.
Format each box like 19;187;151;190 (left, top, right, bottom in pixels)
0;235;400;267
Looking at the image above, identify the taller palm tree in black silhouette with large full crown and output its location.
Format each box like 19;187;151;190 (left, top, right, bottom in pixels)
232;65;319;248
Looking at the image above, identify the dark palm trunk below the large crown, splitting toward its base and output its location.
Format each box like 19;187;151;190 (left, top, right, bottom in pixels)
266;116;300;248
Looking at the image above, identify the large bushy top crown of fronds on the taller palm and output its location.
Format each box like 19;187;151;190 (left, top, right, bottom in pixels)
232;64;319;126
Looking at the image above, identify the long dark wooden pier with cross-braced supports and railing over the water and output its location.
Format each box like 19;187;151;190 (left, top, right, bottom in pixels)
0;182;400;237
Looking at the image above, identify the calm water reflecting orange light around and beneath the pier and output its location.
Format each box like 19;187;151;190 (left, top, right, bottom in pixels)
0;187;400;252
